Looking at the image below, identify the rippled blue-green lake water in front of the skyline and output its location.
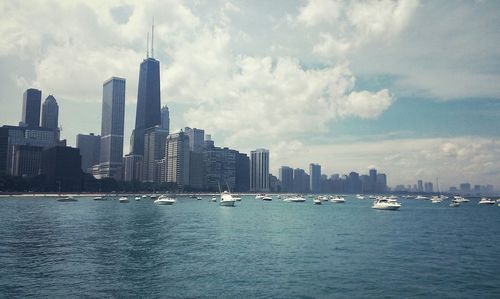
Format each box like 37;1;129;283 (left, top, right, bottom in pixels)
0;196;500;298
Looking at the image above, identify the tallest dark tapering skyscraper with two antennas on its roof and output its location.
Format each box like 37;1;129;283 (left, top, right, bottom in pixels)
132;21;161;155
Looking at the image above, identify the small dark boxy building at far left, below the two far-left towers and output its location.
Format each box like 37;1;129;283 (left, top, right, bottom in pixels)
13;145;43;177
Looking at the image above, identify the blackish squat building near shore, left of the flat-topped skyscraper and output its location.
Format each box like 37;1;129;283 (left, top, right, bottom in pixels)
41;146;83;192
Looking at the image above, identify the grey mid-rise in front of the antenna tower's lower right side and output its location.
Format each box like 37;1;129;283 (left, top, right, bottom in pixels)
142;126;168;183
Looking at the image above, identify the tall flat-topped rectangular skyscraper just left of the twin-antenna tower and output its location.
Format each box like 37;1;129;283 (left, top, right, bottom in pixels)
99;77;125;179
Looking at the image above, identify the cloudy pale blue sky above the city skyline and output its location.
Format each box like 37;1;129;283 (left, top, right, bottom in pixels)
0;0;500;189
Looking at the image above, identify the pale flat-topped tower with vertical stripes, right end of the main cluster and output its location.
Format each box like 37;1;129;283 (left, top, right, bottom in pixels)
250;149;269;192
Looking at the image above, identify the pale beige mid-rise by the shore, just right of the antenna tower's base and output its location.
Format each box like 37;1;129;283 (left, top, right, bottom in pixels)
165;131;190;189
